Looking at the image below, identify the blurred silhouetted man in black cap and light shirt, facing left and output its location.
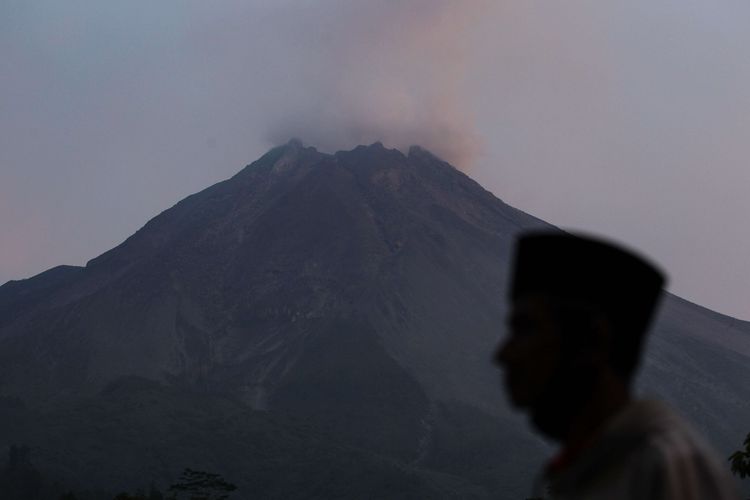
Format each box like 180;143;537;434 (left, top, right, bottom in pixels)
496;232;738;500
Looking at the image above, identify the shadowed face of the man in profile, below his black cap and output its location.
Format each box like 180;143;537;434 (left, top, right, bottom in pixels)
495;296;562;408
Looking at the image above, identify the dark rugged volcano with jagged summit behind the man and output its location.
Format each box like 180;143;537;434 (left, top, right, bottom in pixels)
0;140;750;499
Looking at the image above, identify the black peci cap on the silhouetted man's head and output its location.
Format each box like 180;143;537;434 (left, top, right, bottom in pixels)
510;231;665;342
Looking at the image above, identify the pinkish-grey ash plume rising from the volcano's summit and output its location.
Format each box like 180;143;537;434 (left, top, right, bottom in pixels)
258;0;491;169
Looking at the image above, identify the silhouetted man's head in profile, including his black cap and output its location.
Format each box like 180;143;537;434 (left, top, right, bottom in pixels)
496;232;664;438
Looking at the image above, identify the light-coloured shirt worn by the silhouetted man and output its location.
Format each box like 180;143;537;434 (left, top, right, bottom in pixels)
537;400;740;500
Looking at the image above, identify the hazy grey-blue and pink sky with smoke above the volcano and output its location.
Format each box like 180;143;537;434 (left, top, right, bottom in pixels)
0;0;750;319
